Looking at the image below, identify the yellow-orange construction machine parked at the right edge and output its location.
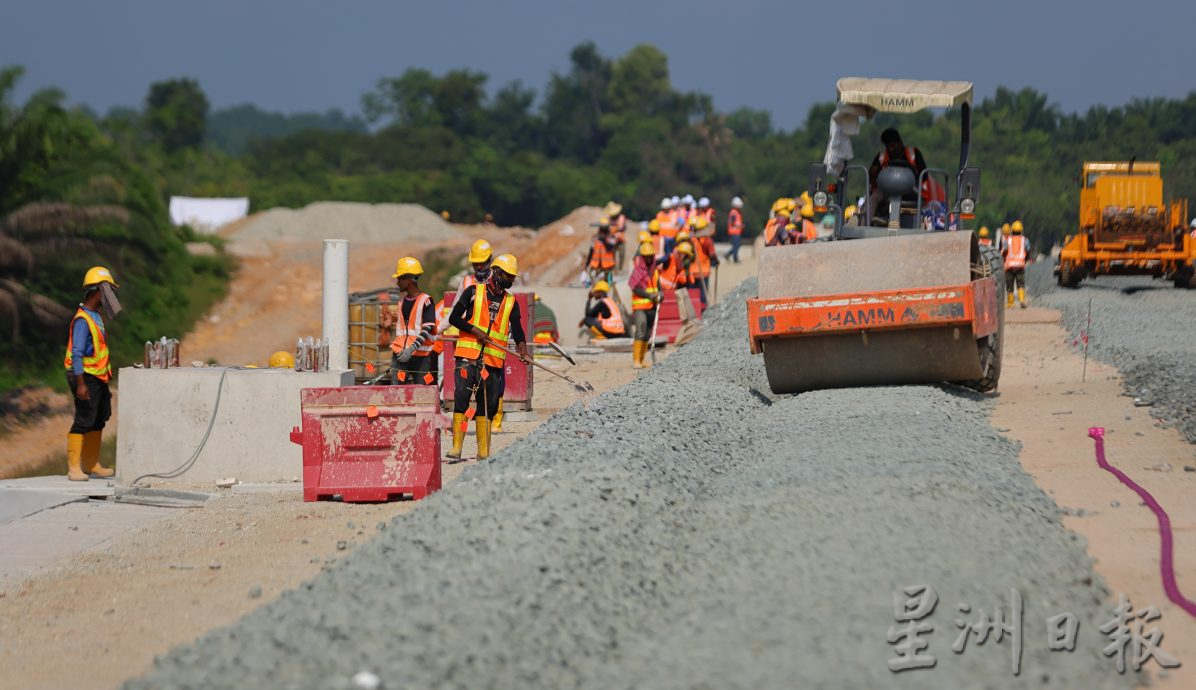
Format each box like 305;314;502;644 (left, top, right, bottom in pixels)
1055;160;1196;288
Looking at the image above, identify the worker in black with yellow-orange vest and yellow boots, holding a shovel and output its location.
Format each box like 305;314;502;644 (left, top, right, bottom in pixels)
447;254;531;459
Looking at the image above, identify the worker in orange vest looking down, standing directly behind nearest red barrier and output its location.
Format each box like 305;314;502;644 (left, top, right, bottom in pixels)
390;256;440;385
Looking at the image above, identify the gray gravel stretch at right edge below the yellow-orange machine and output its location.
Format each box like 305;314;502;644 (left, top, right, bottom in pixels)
1026;263;1196;444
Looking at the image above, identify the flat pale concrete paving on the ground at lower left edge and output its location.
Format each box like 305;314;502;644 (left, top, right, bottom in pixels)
0;501;173;586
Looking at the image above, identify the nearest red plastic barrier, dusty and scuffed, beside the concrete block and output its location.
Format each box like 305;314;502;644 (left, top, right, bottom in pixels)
291;385;447;502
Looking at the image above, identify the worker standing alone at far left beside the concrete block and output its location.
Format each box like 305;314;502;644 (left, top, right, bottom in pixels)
62;265;121;482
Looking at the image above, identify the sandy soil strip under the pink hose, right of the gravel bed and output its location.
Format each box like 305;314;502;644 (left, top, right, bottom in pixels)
993;309;1196;689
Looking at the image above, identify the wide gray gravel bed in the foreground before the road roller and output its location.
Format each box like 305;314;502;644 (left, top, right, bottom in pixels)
126;281;1133;690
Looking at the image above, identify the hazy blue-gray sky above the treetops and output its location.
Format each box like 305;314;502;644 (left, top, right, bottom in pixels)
0;0;1196;128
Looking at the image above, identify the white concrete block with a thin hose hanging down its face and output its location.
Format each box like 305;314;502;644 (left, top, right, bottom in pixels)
116;367;353;484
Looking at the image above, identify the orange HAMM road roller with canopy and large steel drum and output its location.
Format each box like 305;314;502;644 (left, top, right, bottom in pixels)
748;78;1005;393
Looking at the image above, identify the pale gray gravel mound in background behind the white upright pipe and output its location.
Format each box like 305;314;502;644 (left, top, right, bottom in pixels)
236;201;459;243
